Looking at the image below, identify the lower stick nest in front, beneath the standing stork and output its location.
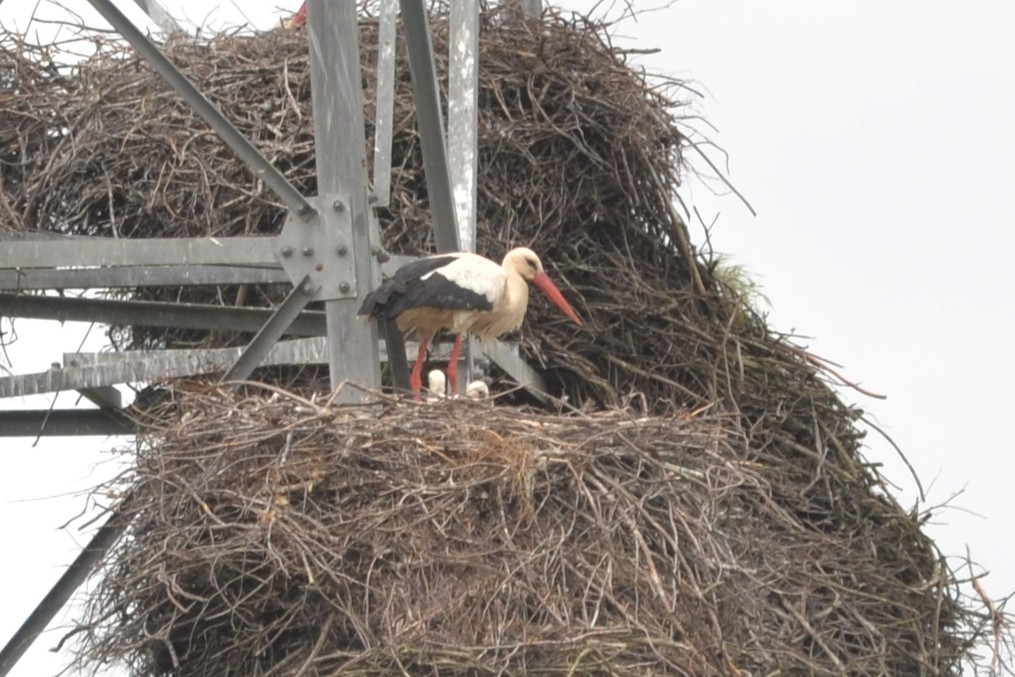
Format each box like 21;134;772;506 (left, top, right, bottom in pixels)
73;385;972;676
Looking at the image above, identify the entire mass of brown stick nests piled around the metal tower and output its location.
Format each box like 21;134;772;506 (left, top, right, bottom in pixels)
0;5;998;675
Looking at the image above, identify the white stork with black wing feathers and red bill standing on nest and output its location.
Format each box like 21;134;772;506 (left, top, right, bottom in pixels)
359;247;582;395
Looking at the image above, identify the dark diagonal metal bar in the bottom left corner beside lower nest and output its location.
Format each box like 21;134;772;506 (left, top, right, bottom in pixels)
0;497;133;677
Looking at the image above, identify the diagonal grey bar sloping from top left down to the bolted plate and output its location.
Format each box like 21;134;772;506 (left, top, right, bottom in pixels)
88;0;314;216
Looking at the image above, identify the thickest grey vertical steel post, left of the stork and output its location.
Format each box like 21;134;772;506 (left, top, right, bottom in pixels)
308;0;381;401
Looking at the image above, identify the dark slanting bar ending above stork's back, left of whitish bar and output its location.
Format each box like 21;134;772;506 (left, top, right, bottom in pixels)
399;0;461;253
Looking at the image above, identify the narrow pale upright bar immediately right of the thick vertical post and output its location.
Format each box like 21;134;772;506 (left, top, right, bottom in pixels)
370;0;398;207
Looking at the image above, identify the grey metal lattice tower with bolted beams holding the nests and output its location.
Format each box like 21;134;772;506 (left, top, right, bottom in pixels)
0;0;543;677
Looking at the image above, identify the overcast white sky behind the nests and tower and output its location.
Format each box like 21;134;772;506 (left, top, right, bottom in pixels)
0;0;1015;677
